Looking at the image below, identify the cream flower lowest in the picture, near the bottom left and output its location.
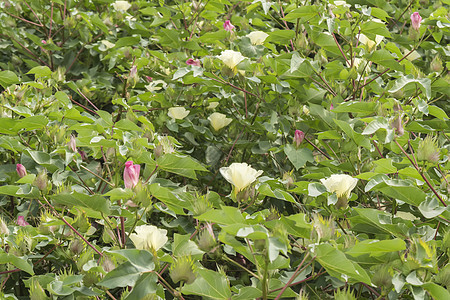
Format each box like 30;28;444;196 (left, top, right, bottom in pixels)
130;225;168;251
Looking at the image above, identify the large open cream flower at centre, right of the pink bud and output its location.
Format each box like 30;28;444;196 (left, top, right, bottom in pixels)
220;163;263;193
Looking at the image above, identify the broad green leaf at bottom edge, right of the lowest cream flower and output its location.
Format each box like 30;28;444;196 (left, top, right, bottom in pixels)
183;269;231;299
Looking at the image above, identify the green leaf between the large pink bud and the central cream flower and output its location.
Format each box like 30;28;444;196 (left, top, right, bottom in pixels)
156;153;208;179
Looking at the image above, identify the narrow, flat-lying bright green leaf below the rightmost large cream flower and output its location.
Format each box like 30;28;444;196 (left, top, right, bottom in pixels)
345;239;406;257
